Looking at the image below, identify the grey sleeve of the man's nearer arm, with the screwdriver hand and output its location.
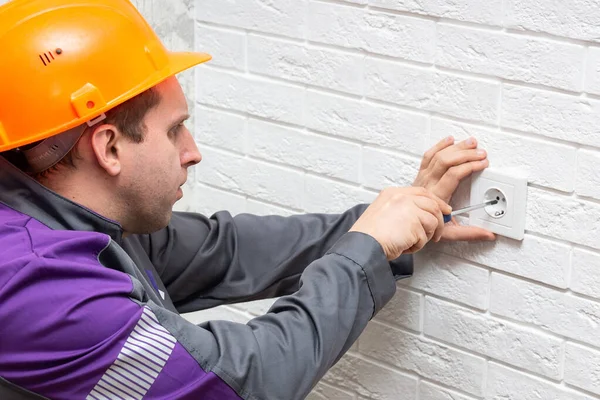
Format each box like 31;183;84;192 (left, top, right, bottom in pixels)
149;232;396;400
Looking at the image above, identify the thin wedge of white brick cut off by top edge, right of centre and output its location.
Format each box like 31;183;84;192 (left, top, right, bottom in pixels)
370;0;502;25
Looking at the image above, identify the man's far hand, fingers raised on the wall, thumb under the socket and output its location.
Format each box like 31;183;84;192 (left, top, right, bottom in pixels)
413;136;496;241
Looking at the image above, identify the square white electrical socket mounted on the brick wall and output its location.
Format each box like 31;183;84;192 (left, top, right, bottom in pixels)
469;168;527;240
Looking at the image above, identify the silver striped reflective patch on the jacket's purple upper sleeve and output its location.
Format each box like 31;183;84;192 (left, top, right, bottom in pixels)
86;307;176;400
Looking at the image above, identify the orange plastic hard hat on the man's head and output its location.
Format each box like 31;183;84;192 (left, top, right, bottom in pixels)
0;0;211;152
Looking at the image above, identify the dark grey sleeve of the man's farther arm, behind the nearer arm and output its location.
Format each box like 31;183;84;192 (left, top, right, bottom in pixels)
140;205;413;312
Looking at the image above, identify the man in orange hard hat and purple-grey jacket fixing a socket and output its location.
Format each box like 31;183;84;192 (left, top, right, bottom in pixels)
0;0;493;399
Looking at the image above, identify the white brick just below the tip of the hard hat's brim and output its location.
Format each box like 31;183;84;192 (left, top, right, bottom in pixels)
196;68;304;124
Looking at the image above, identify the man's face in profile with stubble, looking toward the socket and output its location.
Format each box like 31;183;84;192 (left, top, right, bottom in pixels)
120;78;202;233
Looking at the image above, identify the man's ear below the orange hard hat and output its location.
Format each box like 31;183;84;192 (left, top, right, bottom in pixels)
91;124;125;176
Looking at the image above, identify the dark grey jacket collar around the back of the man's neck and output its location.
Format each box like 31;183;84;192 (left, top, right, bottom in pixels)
0;155;123;243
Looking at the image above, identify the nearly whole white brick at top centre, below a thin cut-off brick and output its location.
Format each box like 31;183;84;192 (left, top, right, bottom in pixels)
307;2;435;63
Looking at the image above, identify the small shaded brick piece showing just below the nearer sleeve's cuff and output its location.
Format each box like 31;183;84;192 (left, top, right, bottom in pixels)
375;287;423;332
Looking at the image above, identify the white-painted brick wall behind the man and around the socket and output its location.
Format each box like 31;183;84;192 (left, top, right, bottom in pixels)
188;0;600;400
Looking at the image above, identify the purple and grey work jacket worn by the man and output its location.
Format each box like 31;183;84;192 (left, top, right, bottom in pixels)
0;156;412;400
